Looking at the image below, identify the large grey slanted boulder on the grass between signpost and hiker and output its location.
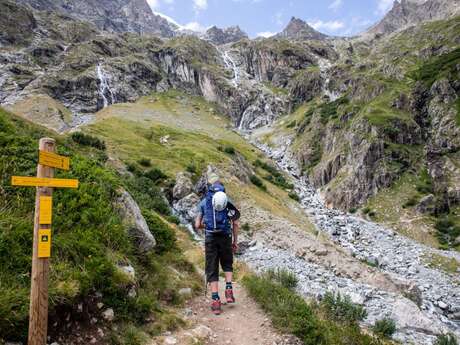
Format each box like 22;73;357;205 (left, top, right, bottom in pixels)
116;189;156;253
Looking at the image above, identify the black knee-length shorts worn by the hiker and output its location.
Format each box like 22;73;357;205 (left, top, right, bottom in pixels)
205;234;233;283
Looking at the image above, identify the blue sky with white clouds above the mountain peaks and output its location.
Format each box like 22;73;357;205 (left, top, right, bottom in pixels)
147;0;394;37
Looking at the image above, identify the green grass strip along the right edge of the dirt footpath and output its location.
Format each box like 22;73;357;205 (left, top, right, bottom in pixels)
243;274;386;345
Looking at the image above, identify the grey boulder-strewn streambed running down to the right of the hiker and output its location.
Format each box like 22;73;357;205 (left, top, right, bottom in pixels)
244;137;460;344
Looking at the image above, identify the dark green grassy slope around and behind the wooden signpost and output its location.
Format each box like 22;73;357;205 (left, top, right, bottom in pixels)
0;109;199;344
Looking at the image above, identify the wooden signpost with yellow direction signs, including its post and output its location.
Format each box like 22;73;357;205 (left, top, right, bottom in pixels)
11;138;78;345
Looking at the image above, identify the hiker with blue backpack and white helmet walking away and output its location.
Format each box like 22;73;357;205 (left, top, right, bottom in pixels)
195;173;240;315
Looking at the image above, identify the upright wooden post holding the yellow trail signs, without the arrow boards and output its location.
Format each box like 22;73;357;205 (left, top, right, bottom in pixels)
28;138;56;345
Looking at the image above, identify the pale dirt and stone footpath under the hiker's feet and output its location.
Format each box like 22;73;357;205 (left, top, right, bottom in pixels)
151;284;301;345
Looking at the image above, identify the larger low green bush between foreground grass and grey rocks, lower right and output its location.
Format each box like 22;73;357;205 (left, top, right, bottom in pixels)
321;292;367;323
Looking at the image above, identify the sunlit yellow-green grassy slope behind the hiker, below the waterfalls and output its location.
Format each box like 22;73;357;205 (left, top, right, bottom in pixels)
86;91;312;230
